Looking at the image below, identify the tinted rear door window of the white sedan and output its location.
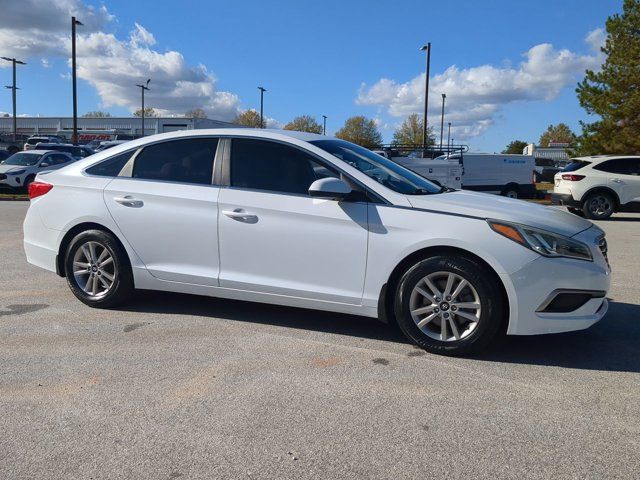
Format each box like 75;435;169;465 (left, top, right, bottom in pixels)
132;138;218;185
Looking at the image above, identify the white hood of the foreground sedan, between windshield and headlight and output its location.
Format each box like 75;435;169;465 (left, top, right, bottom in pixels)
407;190;593;237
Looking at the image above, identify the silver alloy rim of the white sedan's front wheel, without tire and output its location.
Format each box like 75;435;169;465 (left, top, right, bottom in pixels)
409;272;482;342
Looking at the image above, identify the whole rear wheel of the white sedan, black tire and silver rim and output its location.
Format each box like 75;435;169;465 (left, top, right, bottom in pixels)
65;230;134;308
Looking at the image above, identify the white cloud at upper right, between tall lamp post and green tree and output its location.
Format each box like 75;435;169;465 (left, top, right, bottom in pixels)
356;29;605;139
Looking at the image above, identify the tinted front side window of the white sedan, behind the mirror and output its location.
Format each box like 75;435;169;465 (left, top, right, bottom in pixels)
230;138;338;195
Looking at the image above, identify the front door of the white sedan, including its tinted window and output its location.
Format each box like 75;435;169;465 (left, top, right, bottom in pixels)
219;138;368;305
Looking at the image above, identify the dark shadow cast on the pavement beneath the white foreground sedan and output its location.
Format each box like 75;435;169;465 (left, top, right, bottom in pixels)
122;291;640;372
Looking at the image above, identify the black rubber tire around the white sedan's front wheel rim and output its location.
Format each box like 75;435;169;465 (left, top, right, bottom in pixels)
394;255;505;356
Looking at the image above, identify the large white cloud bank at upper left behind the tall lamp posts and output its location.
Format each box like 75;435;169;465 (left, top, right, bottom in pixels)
0;0;240;120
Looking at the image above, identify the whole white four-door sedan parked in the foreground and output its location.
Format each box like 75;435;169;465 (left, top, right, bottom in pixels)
24;129;610;354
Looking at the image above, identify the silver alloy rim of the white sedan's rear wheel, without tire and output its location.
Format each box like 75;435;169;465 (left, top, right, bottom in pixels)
73;241;117;298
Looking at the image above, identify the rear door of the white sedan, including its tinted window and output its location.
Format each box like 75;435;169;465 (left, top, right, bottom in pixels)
104;138;220;286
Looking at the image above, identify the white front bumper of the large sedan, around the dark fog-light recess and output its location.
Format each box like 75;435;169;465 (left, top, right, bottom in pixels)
501;227;611;335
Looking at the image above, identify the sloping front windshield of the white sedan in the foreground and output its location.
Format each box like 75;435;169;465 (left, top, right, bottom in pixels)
310;140;443;195
